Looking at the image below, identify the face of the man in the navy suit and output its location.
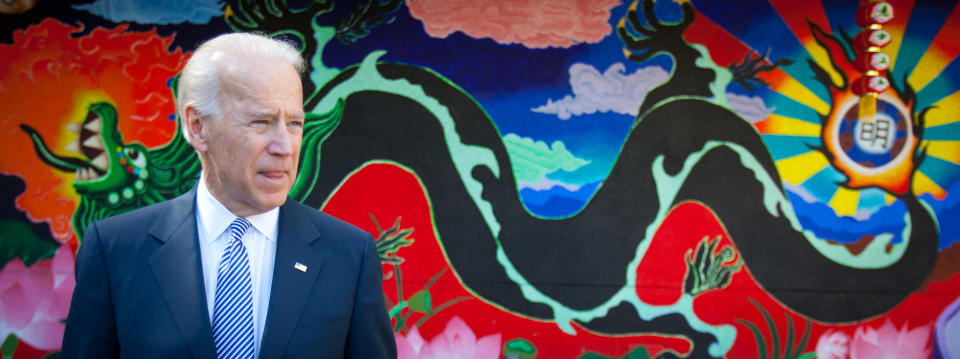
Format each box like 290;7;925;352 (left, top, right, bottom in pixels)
200;61;304;217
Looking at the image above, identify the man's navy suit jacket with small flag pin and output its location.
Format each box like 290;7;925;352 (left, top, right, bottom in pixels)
62;187;396;359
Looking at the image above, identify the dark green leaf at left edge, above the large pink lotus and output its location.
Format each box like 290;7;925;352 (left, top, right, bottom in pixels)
0;219;60;268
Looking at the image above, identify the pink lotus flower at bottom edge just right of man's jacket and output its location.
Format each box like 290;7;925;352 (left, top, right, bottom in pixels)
393;316;500;359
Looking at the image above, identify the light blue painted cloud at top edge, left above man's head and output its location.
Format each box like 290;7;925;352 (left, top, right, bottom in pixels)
73;0;224;25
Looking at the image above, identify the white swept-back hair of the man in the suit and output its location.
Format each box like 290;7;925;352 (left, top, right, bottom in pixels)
176;33;306;142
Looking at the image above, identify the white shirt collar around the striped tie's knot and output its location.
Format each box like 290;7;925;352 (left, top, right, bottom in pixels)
197;172;280;244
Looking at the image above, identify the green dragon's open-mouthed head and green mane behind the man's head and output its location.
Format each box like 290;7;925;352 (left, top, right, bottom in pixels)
20;79;343;239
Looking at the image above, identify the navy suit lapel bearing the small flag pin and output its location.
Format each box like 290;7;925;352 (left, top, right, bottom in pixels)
260;198;323;358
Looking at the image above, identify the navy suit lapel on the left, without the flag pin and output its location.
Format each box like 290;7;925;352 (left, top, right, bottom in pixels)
148;187;217;358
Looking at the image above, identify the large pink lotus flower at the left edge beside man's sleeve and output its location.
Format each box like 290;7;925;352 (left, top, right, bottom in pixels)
0;245;76;350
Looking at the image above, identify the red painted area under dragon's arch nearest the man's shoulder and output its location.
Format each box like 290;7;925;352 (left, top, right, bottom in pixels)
323;164;690;358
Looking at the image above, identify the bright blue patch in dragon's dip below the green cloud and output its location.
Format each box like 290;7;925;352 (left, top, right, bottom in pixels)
520;181;601;218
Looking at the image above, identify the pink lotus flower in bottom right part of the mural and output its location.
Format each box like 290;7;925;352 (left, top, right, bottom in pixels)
850;319;931;359
